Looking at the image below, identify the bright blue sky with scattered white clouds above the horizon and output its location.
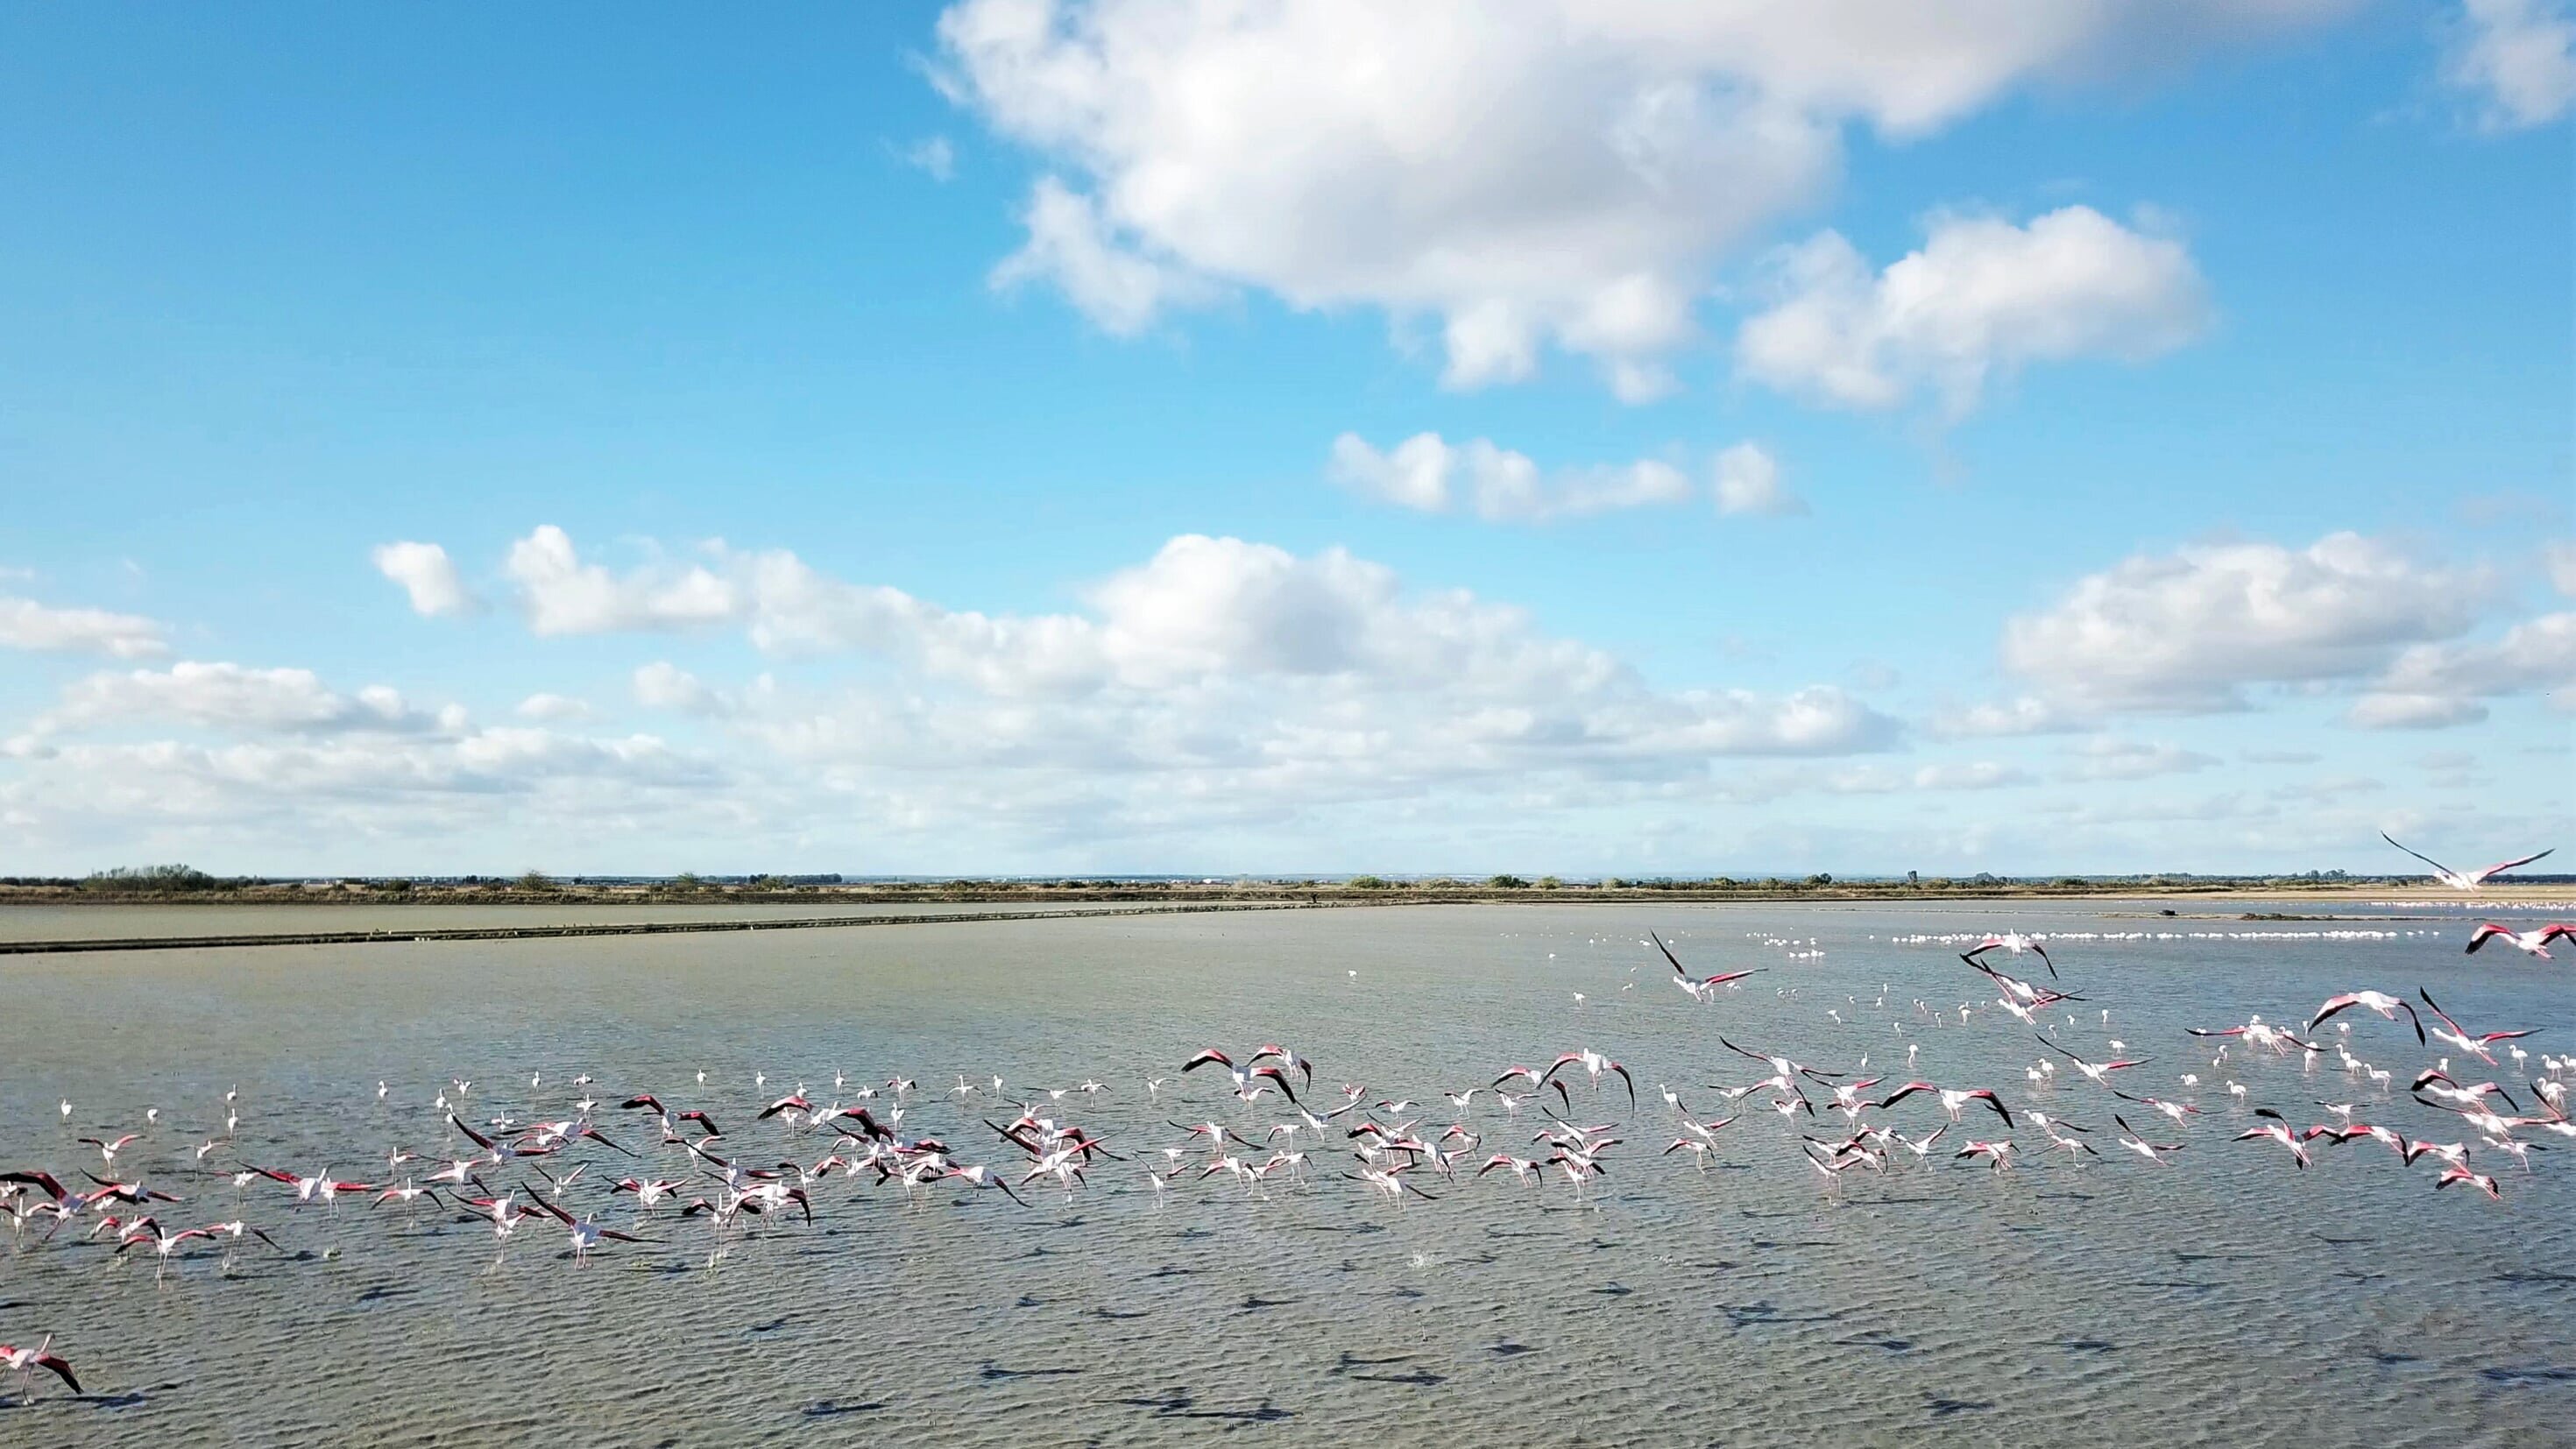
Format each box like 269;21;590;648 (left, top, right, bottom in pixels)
0;0;2576;875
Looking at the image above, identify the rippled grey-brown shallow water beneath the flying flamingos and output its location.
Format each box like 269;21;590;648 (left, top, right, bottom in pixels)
0;903;2576;1444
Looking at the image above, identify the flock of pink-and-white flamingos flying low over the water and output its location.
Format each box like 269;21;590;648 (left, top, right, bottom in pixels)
0;842;2576;1400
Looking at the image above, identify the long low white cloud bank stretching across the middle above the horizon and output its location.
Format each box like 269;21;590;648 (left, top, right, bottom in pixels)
368;530;1901;829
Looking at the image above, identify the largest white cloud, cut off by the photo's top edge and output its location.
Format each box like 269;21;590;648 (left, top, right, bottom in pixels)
938;0;2346;399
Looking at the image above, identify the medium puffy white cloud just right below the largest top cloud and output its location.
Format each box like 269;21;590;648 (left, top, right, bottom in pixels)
1737;206;2211;417
